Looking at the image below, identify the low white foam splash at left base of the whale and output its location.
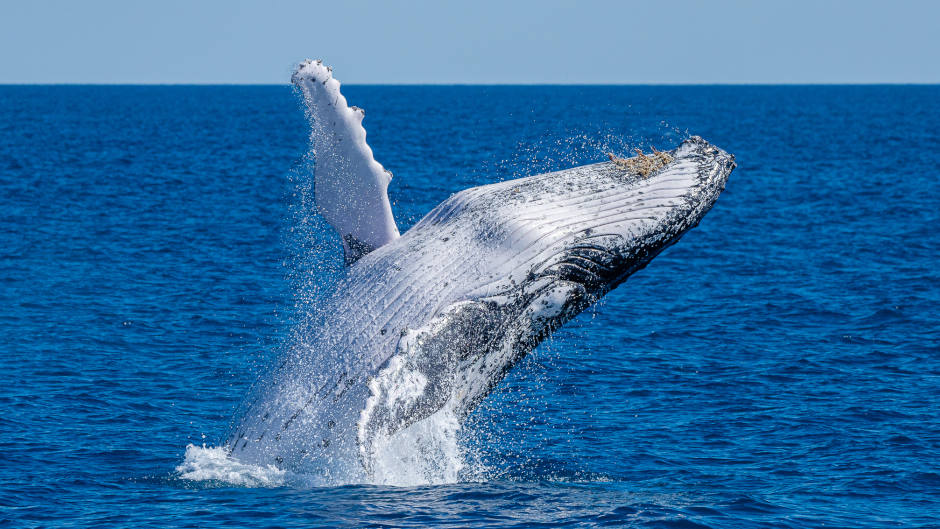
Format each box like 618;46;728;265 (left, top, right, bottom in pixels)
176;444;288;487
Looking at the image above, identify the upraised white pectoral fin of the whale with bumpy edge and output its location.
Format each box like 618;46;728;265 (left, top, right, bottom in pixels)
291;60;399;264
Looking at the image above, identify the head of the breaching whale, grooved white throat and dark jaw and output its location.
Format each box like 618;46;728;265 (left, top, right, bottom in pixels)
458;137;735;308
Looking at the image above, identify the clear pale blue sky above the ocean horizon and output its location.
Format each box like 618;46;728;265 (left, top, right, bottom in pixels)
0;0;940;84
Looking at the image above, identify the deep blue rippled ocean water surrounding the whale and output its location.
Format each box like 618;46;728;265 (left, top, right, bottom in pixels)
0;86;940;528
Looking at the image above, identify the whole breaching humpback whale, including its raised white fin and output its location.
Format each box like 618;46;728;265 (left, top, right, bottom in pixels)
227;61;734;482
